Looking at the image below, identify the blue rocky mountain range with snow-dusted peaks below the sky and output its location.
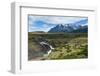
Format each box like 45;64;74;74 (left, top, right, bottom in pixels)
48;19;88;33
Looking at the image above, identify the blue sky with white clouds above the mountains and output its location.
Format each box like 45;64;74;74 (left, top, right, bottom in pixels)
28;15;88;32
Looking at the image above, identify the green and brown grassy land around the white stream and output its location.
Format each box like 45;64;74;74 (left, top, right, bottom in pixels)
28;32;88;60
